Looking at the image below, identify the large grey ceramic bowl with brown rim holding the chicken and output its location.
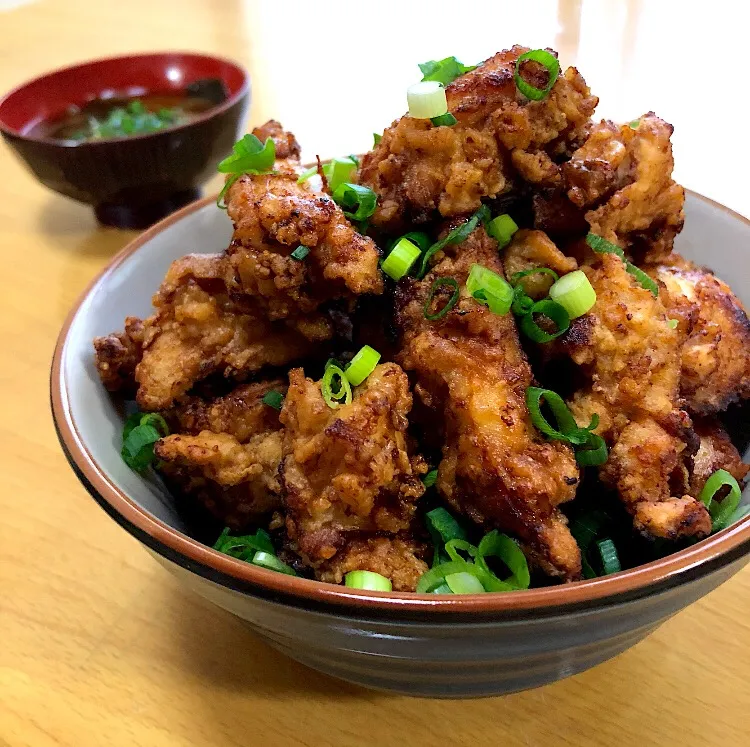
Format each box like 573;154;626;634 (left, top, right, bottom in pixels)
51;194;750;697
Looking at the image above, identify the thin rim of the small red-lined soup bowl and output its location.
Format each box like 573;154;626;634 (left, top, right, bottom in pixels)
0;50;250;145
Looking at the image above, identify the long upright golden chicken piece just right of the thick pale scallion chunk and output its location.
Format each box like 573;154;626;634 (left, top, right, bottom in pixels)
561;254;711;539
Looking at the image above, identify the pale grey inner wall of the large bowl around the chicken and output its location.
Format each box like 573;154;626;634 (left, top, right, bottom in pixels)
53;193;750;588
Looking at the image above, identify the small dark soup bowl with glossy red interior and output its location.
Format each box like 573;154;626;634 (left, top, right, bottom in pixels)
0;52;250;228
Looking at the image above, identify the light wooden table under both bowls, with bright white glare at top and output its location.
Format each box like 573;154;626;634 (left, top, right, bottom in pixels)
0;0;750;747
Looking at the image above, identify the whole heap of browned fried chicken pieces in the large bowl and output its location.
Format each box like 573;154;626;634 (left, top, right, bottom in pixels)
94;46;750;591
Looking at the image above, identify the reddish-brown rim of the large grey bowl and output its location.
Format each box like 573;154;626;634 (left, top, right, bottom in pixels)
50;190;750;620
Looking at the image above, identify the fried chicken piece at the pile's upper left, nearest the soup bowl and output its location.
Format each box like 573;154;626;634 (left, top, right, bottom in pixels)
226;123;383;340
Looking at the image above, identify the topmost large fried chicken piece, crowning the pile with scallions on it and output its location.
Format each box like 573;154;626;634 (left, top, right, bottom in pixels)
359;46;598;232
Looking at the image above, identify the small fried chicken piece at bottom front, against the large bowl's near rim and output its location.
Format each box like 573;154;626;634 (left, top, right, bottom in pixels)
315;536;428;591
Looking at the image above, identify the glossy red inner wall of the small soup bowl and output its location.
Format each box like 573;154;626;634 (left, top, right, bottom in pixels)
0;52;246;136
